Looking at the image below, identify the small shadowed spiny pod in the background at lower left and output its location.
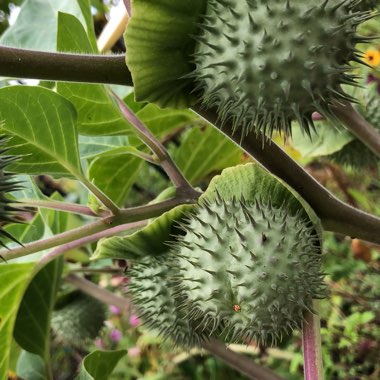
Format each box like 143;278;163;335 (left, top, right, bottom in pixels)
51;293;106;348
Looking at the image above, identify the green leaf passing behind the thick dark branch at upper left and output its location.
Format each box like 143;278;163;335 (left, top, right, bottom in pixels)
57;13;131;135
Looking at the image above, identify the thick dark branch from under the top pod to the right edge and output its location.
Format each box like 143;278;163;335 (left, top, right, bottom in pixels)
193;106;380;244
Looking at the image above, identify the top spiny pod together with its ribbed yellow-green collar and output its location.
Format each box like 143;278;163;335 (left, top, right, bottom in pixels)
125;0;371;135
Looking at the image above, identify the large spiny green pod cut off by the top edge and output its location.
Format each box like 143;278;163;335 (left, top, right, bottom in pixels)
192;0;365;135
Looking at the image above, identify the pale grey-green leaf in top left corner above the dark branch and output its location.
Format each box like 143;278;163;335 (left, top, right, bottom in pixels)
0;0;88;51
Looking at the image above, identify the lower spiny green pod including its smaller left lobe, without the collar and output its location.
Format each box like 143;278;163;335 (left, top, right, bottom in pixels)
130;197;325;346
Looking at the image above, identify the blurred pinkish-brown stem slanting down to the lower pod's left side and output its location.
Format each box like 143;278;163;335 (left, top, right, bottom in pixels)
65;274;131;312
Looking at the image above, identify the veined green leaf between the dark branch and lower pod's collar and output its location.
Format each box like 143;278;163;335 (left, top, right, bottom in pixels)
174;125;242;184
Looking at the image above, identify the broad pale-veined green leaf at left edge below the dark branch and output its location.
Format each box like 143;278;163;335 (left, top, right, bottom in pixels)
0;86;81;176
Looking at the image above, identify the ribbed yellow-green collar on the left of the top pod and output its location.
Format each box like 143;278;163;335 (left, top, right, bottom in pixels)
124;0;207;108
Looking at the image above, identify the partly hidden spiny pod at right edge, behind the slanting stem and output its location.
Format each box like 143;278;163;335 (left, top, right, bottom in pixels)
328;91;380;169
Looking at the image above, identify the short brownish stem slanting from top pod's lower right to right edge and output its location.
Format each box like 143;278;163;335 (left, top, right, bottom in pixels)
332;102;380;157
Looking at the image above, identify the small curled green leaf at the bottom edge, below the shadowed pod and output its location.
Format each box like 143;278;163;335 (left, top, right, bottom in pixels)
77;350;127;380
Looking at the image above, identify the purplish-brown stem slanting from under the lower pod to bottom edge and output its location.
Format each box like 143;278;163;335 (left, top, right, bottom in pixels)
202;339;283;380
